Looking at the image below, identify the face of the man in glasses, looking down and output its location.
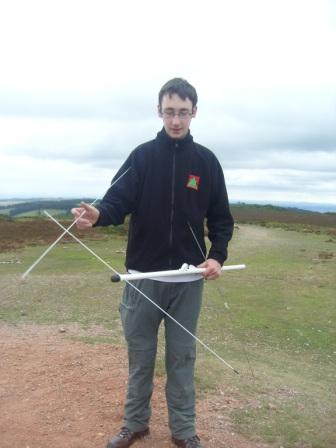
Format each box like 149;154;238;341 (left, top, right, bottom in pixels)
158;93;197;138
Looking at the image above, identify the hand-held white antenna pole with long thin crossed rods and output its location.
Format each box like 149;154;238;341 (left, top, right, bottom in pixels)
22;170;245;374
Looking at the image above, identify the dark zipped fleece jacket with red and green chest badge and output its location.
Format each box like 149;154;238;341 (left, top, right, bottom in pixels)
96;129;233;272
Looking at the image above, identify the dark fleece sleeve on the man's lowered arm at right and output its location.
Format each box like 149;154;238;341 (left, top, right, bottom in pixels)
206;159;234;265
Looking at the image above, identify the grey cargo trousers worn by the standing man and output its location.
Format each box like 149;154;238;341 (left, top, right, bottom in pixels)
120;279;203;439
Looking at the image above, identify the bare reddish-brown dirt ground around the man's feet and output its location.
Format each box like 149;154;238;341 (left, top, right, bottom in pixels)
0;325;265;448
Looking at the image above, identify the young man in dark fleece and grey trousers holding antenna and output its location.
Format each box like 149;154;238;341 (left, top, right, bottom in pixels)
73;78;233;448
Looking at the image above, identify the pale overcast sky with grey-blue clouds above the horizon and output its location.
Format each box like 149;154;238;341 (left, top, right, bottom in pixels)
0;0;336;204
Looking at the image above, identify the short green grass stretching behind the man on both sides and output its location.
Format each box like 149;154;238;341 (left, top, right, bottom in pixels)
0;212;336;448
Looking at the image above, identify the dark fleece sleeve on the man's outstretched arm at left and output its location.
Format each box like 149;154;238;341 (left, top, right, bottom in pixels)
95;151;138;226
